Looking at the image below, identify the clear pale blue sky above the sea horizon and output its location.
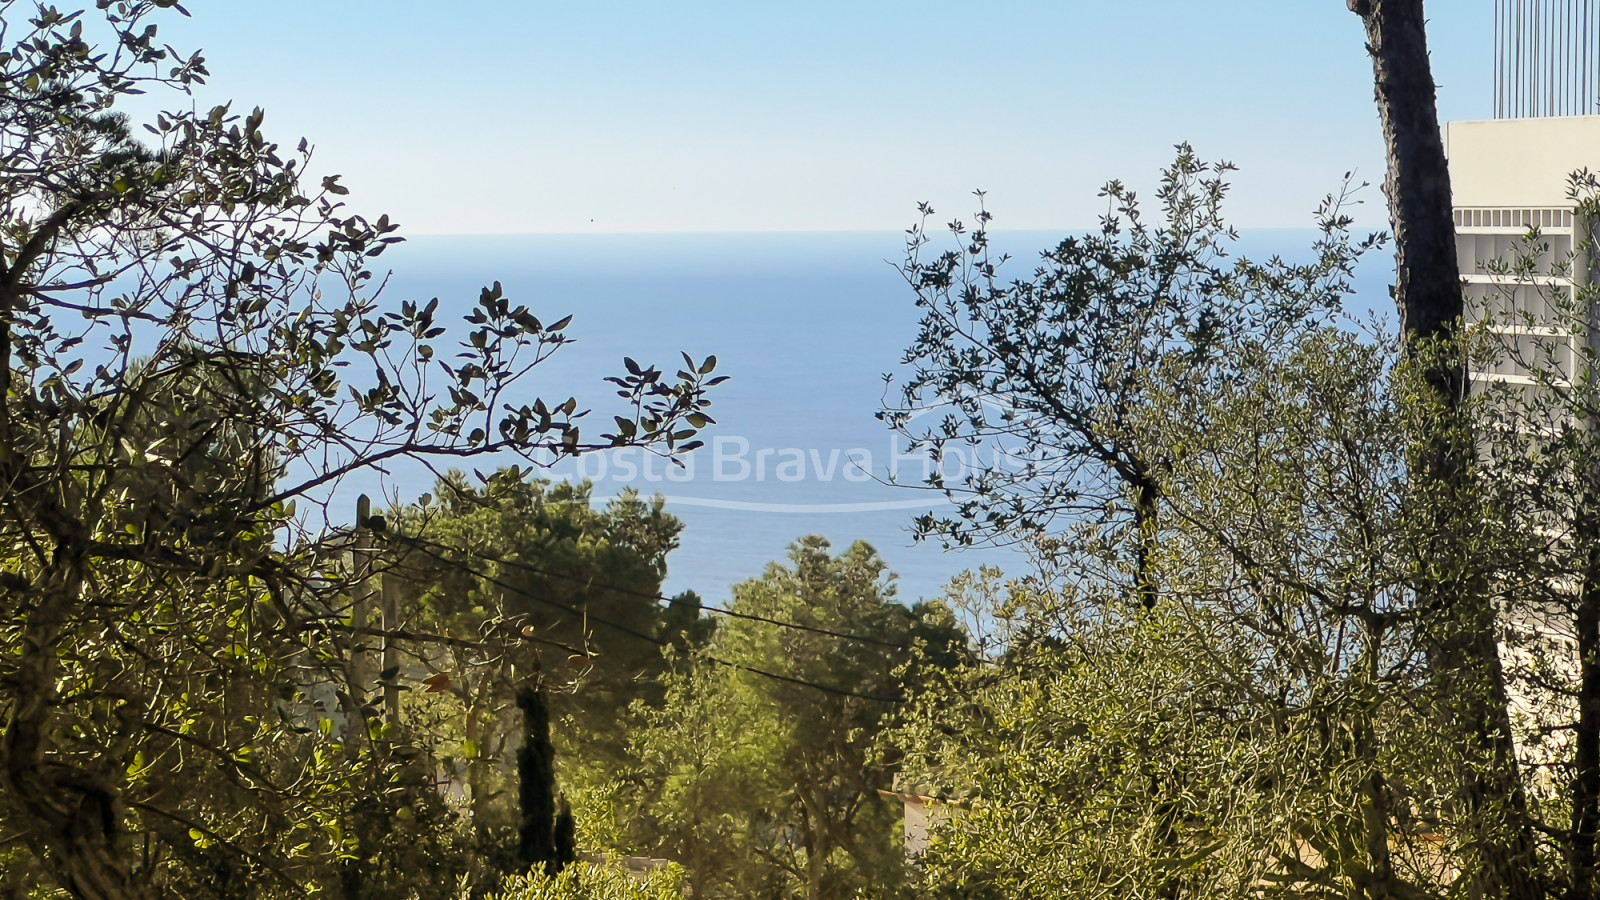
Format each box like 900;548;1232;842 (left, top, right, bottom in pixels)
162;0;1493;234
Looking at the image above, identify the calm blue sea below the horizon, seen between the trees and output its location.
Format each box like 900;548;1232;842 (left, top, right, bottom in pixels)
342;232;1392;602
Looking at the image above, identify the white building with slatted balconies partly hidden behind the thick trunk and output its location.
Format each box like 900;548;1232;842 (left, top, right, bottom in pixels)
1445;0;1600;790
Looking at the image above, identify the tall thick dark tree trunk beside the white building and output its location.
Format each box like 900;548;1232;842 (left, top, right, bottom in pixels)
1349;0;1539;900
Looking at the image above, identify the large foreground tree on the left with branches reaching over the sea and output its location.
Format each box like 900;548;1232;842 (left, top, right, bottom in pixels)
0;0;709;898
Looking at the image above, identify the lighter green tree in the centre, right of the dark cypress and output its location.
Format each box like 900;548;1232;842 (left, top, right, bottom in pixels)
608;536;965;900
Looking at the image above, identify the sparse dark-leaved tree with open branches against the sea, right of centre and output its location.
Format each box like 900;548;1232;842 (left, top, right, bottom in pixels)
880;146;1379;607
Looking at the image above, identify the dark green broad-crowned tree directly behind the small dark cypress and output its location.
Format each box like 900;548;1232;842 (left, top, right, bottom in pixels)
378;469;714;870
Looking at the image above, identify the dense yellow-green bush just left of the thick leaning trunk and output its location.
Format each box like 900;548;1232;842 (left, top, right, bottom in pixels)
894;304;1480;897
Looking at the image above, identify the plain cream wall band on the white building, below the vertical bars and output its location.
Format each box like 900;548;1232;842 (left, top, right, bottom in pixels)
1445;115;1600;208
